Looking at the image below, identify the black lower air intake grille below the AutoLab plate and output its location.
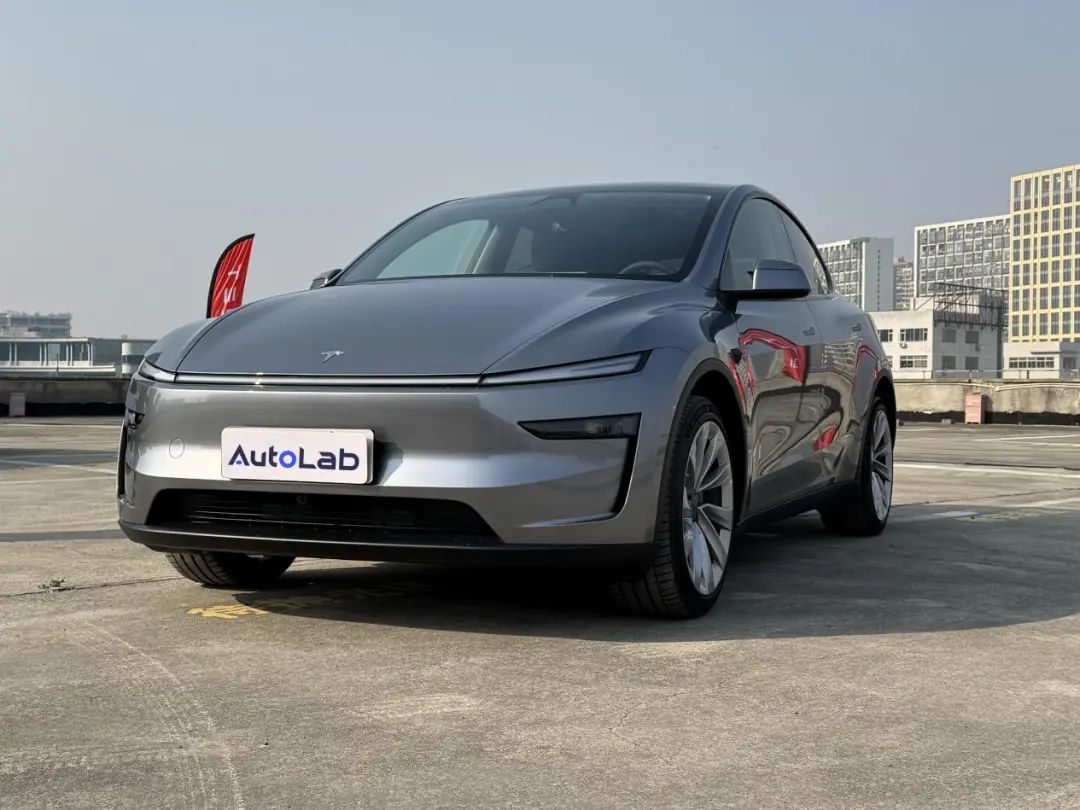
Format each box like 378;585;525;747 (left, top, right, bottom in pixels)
147;489;499;545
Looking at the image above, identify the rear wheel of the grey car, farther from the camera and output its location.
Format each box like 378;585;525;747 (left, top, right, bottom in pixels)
818;399;893;537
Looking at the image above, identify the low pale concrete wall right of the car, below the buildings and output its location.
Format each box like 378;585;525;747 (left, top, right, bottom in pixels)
896;380;1080;424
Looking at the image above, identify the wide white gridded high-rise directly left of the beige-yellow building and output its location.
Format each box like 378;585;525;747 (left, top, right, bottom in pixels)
915;214;1009;296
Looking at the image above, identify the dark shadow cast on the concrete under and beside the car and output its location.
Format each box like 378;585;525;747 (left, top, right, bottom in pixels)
237;504;1080;643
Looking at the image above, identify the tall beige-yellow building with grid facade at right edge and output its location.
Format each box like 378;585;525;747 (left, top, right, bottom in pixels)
1009;164;1080;341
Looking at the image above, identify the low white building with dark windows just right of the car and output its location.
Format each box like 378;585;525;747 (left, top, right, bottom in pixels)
870;298;1002;379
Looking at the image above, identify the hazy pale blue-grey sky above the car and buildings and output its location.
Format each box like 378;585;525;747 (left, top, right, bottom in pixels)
0;0;1080;338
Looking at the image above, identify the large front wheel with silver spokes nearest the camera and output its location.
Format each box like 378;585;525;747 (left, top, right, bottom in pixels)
612;396;738;619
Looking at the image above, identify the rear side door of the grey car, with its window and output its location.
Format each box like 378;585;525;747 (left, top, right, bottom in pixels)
781;206;876;488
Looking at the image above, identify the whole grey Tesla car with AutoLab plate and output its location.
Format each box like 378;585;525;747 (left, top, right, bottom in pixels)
118;185;896;617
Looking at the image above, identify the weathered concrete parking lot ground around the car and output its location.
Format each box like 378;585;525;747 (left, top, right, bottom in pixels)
0;419;1080;808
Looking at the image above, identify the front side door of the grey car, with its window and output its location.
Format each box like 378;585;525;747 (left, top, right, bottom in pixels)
720;198;818;515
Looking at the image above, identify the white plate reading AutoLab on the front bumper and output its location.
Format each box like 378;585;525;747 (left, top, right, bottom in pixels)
221;428;375;484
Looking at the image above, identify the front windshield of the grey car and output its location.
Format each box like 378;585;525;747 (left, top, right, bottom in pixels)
338;191;715;284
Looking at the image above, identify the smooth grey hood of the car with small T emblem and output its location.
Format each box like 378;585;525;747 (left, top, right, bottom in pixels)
176;276;671;376
